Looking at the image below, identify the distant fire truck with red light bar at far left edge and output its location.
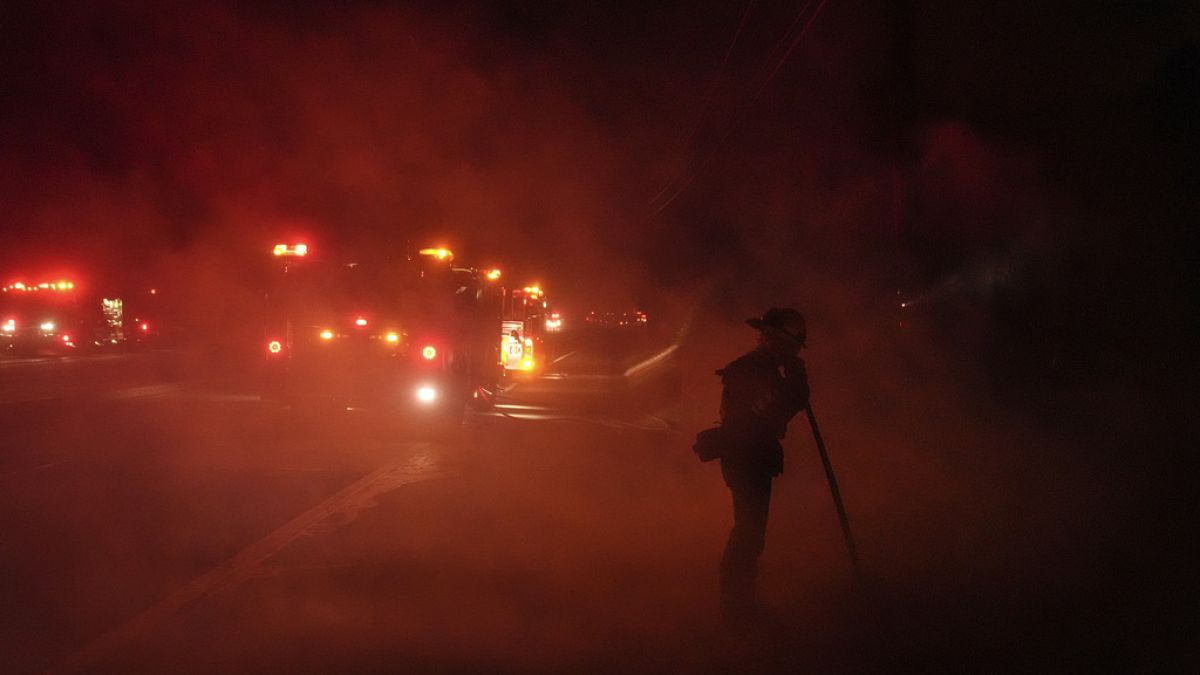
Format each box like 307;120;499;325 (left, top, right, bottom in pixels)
0;279;125;356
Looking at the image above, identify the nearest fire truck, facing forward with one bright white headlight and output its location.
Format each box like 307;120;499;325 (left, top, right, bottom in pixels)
263;244;502;423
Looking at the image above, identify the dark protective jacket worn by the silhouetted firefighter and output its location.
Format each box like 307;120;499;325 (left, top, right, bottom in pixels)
716;348;809;476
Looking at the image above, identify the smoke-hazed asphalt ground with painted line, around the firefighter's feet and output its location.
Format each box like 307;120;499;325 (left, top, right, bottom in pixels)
0;339;1187;673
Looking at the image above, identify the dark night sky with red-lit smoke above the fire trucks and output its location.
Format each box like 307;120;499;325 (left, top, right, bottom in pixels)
0;1;1198;379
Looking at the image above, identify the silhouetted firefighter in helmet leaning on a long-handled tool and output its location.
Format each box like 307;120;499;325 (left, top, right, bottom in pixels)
716;307;809;626
